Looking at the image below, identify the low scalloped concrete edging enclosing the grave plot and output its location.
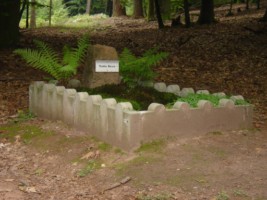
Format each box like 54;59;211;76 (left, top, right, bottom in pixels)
29;82;253;151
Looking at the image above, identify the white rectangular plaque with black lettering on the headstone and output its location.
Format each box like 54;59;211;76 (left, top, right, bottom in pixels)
95;60;119;72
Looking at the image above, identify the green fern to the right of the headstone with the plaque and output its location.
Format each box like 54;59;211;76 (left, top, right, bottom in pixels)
120;48;168;88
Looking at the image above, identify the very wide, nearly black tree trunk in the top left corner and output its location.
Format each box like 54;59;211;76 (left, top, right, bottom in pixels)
0;0;20;47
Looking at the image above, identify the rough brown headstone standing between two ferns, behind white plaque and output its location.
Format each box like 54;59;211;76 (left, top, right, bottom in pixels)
82;44;120;88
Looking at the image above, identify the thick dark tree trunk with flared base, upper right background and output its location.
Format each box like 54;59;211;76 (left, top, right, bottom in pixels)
198;0;215;24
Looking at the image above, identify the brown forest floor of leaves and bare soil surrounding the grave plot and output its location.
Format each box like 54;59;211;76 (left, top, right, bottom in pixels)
0;6;267;200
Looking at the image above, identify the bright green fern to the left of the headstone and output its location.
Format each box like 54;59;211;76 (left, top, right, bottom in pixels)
14;35;89;80
